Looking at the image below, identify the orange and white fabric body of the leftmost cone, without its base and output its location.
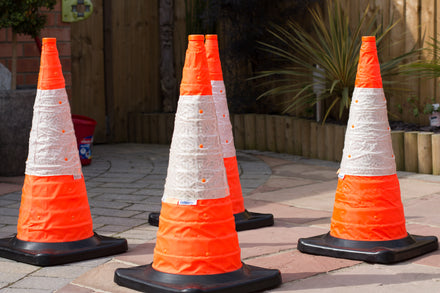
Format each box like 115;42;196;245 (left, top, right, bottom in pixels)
17;38;94;242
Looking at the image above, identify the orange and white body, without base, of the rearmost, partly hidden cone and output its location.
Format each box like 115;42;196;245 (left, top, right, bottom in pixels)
205;35;245;214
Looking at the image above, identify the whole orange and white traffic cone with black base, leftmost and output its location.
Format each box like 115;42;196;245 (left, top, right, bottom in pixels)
0;38;127;266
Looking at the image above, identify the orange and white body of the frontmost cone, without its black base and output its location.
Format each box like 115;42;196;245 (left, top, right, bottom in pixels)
152;35;242;275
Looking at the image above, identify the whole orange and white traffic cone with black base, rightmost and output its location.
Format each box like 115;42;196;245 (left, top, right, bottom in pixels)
298;36;438;263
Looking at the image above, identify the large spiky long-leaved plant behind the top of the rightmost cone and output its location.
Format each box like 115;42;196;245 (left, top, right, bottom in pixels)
255;0;418;122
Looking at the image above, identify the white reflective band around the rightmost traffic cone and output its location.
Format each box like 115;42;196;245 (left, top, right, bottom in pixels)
340;88;396;176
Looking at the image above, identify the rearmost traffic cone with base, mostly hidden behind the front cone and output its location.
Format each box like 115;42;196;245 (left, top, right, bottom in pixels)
148;35;274;231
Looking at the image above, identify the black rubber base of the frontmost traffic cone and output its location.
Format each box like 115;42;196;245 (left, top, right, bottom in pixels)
114;264;281;293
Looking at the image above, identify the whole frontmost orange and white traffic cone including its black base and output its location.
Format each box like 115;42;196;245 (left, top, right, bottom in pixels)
114;35;281;292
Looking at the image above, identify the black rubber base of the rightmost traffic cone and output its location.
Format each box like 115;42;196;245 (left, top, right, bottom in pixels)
298;233;438;264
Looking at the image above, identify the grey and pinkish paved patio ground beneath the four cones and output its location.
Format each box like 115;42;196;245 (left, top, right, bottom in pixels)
0;144;440;293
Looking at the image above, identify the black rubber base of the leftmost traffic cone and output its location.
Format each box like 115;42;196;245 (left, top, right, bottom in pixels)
0;233;128;267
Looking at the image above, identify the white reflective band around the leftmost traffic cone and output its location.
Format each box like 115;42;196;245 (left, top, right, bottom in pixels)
25;88;82;178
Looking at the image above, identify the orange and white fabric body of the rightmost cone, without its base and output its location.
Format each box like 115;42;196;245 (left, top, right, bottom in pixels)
330;37;408;241
